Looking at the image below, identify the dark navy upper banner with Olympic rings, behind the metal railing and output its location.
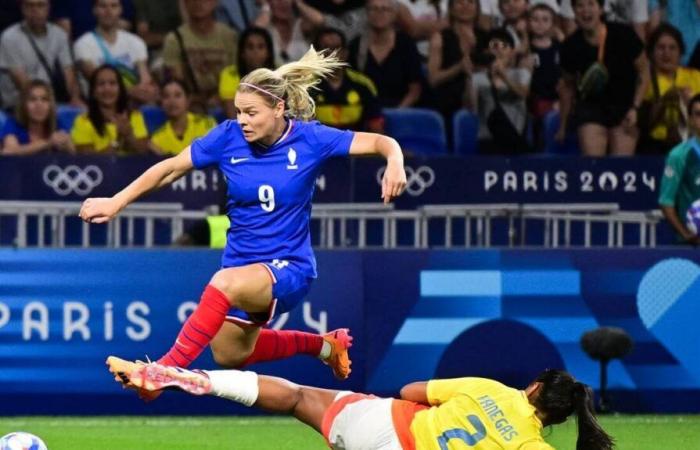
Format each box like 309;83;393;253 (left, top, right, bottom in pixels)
0;154;663;210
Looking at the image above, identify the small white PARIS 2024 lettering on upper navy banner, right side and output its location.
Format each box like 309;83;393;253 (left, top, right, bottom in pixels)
483;170;656;193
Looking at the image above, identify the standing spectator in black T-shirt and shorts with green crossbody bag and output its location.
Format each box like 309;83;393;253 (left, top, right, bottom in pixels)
556;0;649;157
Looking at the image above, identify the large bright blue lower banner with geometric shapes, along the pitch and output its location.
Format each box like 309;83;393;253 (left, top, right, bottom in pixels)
0;249;700;415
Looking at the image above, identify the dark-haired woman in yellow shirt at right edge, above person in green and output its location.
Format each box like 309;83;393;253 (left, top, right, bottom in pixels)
639;24;700;155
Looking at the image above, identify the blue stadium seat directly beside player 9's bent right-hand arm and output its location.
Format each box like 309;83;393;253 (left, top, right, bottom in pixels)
383;108;447;155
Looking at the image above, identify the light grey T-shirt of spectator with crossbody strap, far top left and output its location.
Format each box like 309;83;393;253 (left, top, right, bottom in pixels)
0;23;73;107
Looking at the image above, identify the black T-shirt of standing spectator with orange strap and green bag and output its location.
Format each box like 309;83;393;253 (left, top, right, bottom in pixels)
560;23;644;107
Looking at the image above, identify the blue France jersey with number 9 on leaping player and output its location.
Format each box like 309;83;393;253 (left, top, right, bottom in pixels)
191;120;353;277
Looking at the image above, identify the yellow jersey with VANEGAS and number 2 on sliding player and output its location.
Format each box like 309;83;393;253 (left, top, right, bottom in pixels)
410;378;552;450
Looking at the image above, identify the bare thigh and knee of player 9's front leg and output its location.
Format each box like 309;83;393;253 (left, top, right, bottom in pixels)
210;264;272;313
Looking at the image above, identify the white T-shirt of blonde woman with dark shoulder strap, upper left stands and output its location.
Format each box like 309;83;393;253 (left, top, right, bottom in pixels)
73;30;148;71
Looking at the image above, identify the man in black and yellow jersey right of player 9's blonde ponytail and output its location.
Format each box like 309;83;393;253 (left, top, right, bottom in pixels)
312;28;384;133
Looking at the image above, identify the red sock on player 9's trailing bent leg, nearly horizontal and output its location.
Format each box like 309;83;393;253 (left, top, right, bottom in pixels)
243;328;323;366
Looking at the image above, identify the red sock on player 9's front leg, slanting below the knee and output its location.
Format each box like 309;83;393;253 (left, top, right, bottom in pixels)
158;285;231;367
